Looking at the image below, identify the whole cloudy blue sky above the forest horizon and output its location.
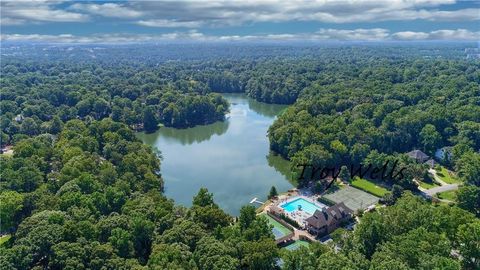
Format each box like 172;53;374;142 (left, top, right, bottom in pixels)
0;0;480;43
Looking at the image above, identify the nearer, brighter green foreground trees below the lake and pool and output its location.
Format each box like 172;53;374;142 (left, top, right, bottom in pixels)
0;119;480;269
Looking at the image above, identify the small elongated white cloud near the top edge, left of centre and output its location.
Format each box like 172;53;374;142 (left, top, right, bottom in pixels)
70;3;143;18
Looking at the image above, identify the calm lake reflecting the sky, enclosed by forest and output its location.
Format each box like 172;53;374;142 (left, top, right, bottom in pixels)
137;94;293;215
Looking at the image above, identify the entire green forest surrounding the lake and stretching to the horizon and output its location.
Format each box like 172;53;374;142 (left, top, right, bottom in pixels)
0;44;480;270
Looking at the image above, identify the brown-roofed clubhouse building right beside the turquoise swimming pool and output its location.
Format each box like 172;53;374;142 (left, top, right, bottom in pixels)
305;202;353;235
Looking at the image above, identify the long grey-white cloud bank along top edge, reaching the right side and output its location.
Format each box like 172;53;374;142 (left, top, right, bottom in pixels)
131;0;480;26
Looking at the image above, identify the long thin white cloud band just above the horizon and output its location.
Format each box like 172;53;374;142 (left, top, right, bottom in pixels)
1;28;480;43
